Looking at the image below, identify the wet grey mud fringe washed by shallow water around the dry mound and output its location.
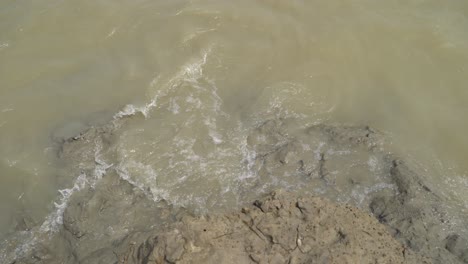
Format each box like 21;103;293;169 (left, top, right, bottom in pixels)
3;119;468;263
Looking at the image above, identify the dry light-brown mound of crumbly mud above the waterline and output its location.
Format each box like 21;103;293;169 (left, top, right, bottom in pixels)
119;193;430;264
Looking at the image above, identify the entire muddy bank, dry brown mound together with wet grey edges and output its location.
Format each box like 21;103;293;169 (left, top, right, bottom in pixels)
3;119;468;264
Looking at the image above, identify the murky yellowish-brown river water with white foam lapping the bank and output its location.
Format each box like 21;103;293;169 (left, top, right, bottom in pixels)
0;0;468;248
